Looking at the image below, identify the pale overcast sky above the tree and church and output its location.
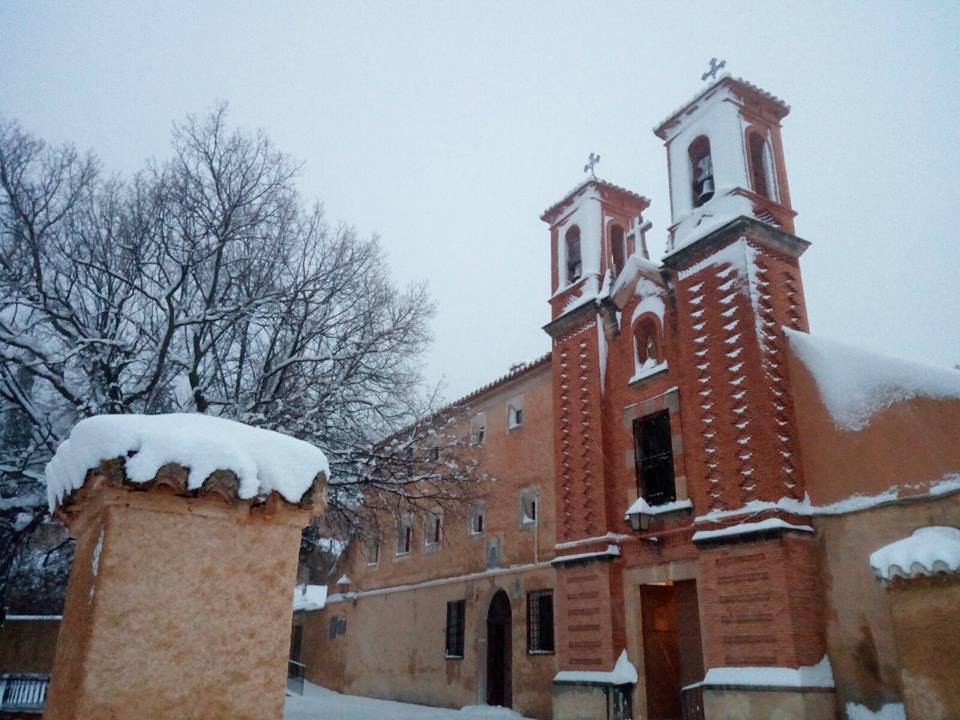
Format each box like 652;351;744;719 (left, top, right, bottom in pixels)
0;0;960;399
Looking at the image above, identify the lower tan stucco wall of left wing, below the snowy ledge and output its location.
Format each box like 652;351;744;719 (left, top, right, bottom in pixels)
297;567;559;718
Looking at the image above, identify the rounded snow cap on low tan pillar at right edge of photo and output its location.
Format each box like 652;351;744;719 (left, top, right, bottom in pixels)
870;525;960;580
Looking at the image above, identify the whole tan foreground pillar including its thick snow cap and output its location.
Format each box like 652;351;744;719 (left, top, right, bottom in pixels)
44;415;328;720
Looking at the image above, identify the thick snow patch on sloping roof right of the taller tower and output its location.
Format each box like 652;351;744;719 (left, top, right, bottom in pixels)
784;328;960;431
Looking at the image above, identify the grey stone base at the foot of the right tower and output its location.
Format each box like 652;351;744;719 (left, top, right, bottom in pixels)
702;686;837;720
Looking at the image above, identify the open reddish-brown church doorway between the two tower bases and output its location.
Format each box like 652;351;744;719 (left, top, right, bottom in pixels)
640;580;703;720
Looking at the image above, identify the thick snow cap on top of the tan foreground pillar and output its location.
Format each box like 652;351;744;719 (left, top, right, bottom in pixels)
46;413;330;512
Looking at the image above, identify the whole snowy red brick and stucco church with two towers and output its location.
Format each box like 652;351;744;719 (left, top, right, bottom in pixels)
293;75;960;720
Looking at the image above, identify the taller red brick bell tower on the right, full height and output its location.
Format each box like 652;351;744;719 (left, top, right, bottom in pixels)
654;76;825;692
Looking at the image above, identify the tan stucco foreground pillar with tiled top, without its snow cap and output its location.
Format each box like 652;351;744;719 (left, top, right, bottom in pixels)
44;461;322;720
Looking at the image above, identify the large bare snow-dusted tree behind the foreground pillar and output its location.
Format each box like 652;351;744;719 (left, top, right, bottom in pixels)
0;106;471;606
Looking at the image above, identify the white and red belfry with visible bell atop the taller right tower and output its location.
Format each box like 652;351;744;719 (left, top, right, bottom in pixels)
654;75;796;252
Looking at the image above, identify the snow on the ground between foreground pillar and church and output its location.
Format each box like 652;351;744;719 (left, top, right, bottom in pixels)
283;682;523;720
